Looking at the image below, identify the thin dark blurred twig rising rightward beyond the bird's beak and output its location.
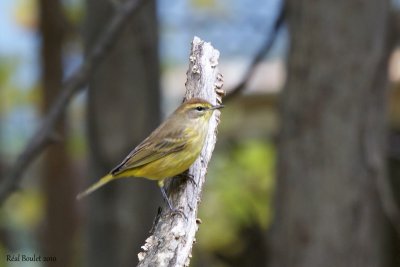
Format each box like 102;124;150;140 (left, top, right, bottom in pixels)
224;4;286;102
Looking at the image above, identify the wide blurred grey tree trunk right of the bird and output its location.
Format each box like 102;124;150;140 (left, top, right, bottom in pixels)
270;0;390;267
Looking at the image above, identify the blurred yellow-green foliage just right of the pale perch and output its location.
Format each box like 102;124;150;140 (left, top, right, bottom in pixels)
198;140;275;253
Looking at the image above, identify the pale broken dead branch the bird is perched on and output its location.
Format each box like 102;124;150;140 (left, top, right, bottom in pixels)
138;37;223;266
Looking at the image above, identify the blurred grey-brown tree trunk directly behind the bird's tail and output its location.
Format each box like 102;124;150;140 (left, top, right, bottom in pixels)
85;0;162;267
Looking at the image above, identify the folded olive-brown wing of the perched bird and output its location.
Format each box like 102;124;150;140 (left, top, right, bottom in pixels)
111;129;187;175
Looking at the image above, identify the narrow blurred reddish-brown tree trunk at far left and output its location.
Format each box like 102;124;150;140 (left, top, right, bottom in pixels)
39;0;76;266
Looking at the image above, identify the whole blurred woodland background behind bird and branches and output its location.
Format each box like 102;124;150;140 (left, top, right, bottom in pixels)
0;0;400;267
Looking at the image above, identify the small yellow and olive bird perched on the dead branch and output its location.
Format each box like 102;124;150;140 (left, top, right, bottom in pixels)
77;98;223;209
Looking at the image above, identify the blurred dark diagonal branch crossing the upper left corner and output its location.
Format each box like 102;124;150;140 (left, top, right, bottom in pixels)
0;0;146;203
